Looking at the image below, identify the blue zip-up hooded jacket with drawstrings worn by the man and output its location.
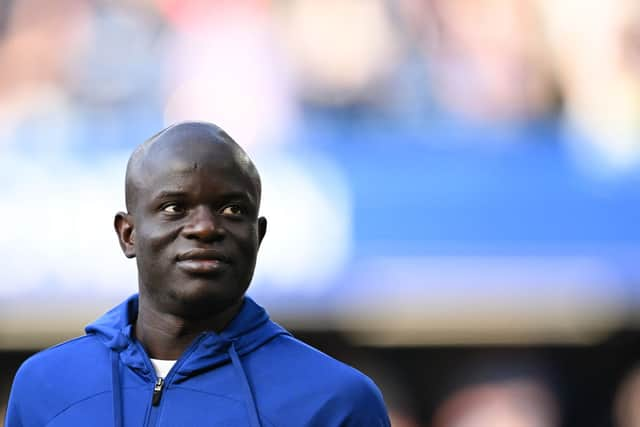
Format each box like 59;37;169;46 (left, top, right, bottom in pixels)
5;296;390;427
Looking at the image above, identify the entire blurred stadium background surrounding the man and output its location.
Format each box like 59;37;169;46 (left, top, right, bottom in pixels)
0;0;640;427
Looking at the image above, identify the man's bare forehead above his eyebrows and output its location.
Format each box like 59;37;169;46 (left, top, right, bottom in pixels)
136;137;258;201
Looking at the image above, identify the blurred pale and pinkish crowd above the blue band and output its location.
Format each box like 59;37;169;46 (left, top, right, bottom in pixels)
0;0;640;169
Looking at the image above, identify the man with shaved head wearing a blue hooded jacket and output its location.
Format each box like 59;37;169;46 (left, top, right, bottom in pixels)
6;123;389;427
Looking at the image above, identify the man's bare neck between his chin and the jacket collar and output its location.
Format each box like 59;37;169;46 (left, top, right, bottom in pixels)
135;294;243;360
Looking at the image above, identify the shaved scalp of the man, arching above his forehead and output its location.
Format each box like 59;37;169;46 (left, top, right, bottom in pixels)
125;122;261;213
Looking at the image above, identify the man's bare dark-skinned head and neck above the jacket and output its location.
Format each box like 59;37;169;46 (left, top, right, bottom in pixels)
114;123;267;360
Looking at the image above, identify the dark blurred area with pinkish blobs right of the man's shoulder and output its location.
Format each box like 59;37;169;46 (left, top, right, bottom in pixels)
354;348;640;427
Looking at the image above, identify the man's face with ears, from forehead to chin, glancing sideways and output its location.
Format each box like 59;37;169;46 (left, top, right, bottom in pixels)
116;140;266;317
